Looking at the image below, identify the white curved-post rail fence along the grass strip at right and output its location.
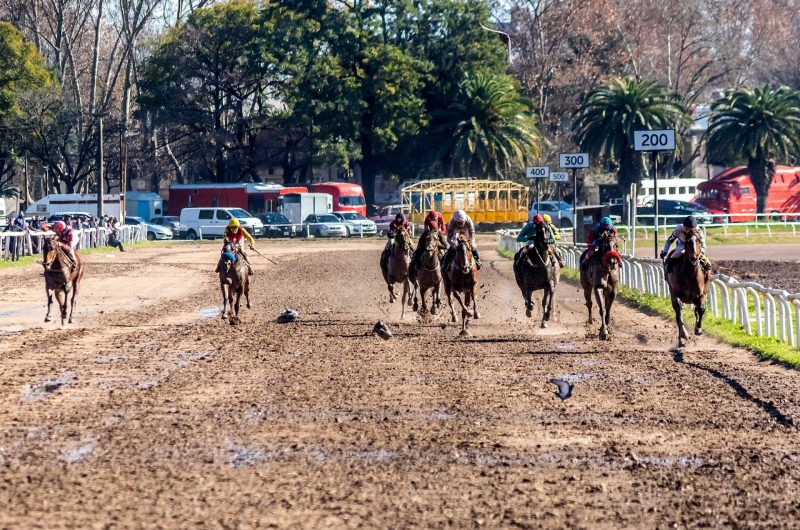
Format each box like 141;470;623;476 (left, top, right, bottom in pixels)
496;230;800;349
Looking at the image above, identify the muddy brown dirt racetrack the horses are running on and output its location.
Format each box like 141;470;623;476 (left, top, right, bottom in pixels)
0;239;800;529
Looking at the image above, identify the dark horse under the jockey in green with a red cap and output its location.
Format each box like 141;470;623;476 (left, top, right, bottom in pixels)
514;226;561;328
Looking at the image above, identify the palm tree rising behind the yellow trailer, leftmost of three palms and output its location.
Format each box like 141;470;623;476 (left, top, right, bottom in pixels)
430;74;541;179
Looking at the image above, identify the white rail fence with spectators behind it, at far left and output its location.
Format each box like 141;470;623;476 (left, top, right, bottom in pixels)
0;225;147;260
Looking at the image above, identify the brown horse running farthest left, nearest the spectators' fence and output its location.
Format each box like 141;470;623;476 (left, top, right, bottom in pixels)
42;238;83;326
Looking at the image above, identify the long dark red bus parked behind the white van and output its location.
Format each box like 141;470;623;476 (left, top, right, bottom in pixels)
169;183;308;215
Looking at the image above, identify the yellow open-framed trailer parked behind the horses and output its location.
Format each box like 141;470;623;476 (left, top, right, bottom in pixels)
401;179;528;224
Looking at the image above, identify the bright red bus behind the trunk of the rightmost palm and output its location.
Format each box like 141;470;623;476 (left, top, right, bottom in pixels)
693;166;800;222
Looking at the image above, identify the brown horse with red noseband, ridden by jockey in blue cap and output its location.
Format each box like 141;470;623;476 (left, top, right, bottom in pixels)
581;232;622;340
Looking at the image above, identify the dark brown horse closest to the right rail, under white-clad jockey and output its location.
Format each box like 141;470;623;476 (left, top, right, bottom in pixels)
667;230;711;348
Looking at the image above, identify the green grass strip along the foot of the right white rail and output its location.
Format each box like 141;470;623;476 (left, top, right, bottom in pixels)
497;246;800;369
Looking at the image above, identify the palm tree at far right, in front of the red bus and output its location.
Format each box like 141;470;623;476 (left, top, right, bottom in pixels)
706;85;800;213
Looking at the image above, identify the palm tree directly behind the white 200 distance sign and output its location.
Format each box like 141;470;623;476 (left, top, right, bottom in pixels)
572;77;689;193
